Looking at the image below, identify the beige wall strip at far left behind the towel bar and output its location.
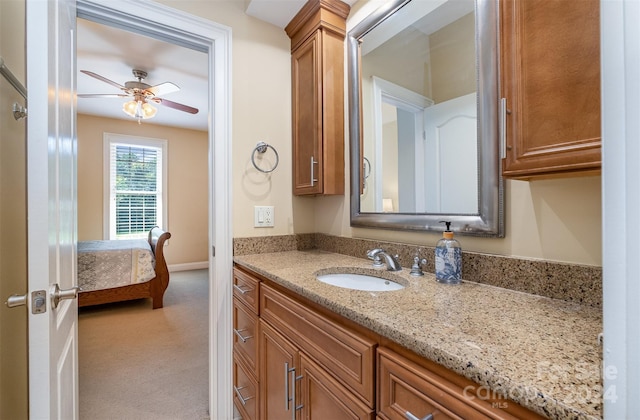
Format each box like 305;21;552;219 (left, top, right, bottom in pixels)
0;0;28;419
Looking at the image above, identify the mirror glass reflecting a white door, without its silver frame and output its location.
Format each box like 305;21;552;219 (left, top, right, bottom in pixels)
360;0;478;214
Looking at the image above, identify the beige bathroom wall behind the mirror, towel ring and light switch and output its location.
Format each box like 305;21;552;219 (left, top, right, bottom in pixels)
154;0;602;266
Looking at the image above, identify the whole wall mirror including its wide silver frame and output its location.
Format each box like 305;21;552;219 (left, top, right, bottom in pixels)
348;0;504;237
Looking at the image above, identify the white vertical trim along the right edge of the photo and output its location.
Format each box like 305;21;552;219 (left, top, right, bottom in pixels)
600;0;640;419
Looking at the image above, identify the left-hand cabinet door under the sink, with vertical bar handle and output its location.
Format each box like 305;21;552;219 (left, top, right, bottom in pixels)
259;320;300;420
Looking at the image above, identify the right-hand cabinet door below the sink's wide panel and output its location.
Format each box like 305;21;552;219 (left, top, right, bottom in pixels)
300;353;374;420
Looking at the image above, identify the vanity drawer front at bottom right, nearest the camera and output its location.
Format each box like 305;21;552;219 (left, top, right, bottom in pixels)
378;347;540;420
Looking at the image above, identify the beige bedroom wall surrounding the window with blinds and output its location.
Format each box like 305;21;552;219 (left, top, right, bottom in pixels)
78;114;209;265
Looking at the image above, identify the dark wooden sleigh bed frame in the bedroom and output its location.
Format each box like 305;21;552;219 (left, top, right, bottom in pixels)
78;227;171;309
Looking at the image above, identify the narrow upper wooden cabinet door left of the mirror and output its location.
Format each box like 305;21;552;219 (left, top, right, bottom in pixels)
291;31;323;195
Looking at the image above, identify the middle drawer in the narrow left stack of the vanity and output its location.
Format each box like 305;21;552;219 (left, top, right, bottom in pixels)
233;298;258;377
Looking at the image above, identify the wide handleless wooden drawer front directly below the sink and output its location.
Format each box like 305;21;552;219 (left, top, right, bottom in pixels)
260;283;377;408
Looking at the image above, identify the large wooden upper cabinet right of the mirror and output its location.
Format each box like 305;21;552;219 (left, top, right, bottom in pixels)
501;0;601;178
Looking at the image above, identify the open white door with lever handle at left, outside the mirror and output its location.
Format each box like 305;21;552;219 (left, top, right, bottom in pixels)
26;0;78;420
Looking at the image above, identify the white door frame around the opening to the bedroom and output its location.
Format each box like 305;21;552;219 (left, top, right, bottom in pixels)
77;0;233;419
